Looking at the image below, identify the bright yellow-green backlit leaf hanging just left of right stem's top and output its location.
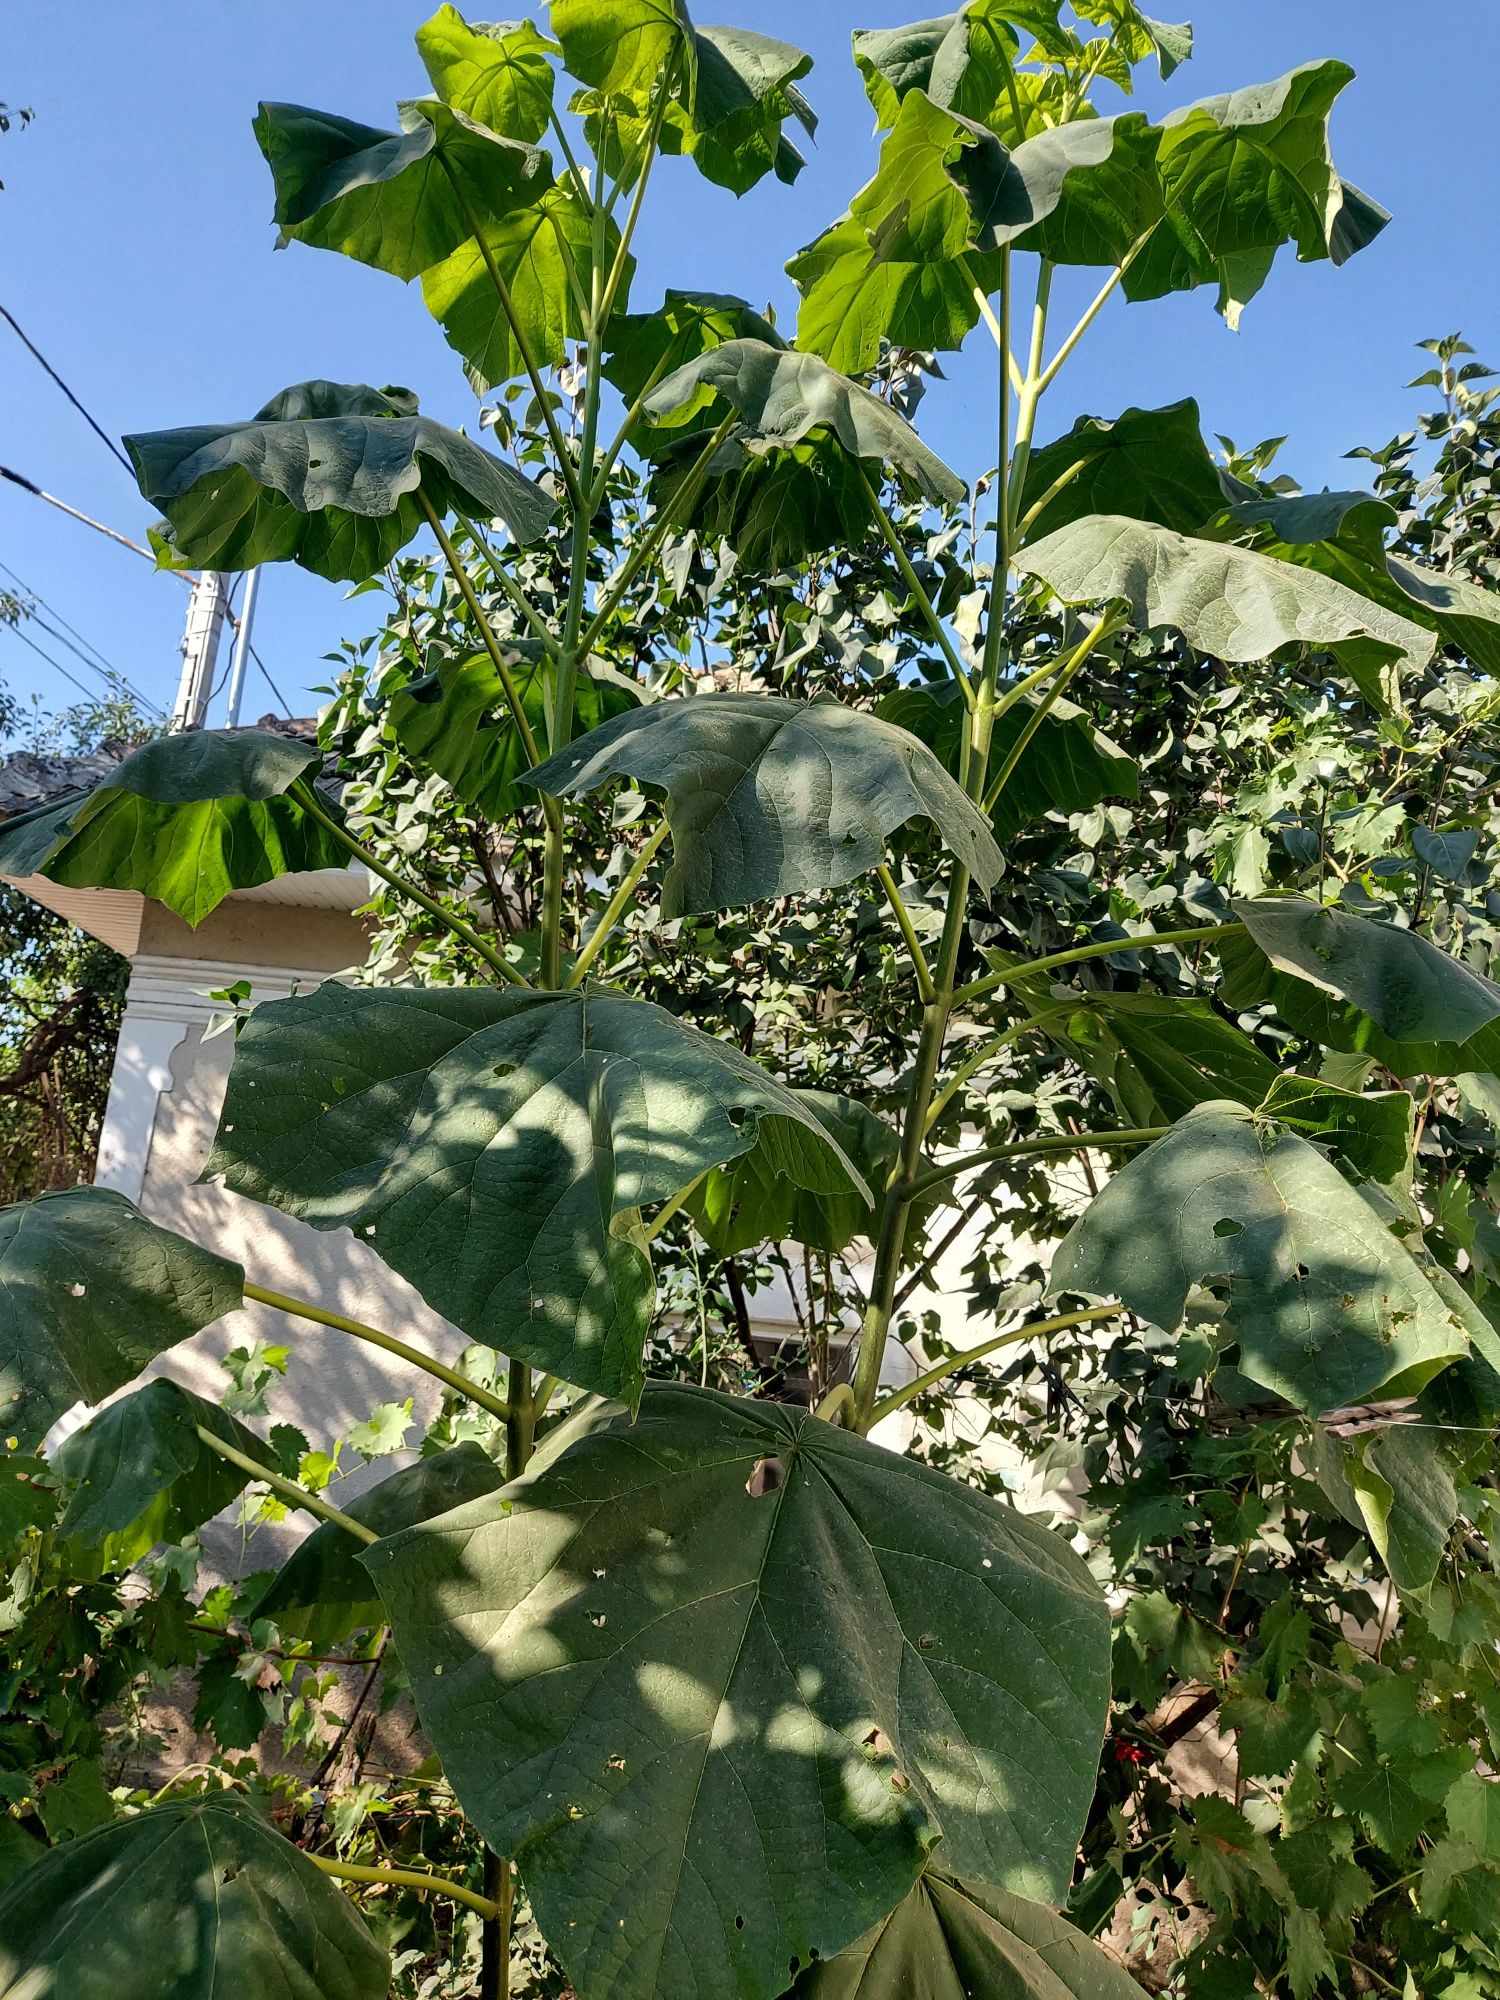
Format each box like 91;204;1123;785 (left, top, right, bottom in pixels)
786;90;1012;374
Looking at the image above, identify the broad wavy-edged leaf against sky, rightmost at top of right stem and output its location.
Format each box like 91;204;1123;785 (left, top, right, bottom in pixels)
1008;62;1390;324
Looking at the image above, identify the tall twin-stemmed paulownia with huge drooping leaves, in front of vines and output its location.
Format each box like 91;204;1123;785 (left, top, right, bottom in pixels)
0;11;1500;2000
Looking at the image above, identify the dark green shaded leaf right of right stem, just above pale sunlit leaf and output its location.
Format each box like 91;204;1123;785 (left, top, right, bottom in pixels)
1020;396;1224;538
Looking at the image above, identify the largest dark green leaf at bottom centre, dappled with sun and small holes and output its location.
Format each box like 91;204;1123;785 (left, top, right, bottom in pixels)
366;1382;1108;2000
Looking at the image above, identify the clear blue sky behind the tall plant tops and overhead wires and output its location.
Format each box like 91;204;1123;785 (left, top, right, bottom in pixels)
0;0;1500;720
